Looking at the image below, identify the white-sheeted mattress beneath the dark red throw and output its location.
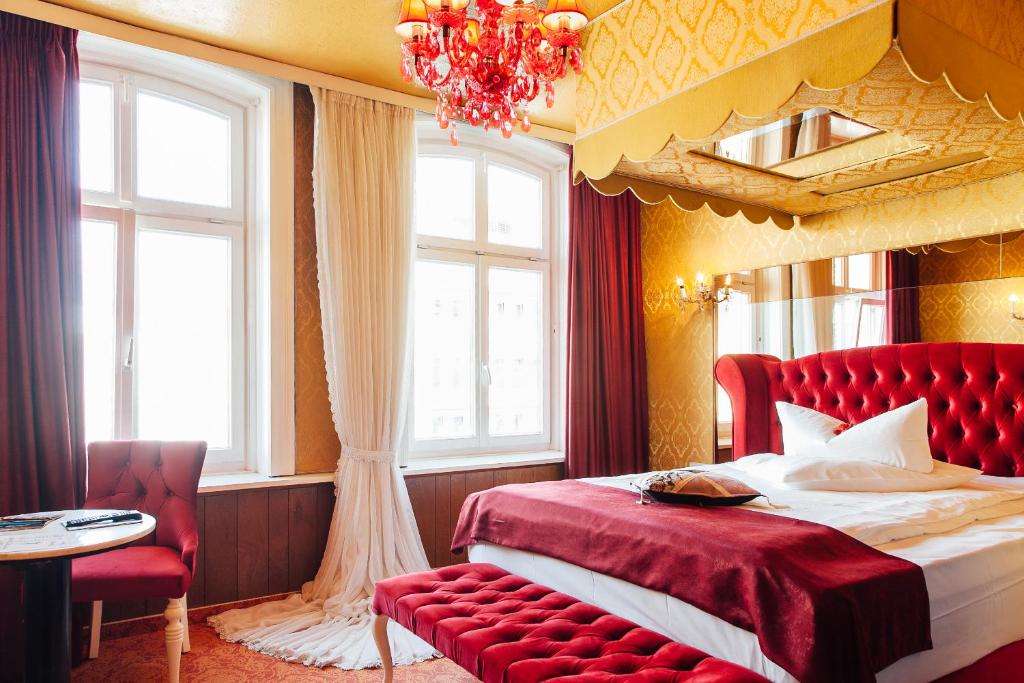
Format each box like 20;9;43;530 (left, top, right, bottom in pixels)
469;466;1024;683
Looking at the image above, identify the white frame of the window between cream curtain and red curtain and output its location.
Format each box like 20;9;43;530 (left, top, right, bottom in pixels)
406;119;568;459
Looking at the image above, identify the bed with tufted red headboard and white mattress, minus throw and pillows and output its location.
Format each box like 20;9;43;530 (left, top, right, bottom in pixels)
469;343;1024;683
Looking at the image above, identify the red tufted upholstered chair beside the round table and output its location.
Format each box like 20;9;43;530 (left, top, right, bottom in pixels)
71;441;206;683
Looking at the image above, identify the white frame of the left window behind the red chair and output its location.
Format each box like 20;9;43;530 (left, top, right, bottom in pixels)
79;34;295;475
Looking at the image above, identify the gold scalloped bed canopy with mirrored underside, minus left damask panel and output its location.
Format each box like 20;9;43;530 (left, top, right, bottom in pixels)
574;0;1024;227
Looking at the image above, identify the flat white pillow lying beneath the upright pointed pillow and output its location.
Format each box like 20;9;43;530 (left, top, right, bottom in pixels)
732;455;981;492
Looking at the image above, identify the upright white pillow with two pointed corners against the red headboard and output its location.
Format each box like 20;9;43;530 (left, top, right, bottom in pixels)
775;398;934;473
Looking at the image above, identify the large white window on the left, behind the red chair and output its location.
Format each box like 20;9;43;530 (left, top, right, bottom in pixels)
80;36;294;474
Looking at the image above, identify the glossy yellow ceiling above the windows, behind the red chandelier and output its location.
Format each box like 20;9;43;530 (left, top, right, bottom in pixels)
41;0;622;131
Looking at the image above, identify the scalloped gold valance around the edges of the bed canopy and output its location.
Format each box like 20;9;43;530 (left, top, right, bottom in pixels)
573;0;1024;227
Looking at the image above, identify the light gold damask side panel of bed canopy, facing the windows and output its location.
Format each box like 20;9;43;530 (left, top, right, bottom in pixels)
577;0;878;134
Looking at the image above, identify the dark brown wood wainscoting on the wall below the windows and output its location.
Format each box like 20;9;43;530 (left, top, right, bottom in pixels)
97;464;564;623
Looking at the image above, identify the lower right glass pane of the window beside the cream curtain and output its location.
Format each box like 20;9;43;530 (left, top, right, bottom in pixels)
487;267;544;436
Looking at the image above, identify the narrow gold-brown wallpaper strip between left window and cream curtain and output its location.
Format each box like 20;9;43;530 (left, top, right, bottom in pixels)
294;85;341;473
